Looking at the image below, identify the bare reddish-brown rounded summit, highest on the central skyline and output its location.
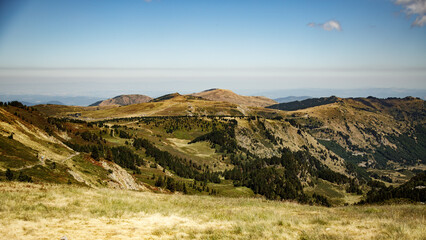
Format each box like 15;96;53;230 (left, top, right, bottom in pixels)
191;89;277;107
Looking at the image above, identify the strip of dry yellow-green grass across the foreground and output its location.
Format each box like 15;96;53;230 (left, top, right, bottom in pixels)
0;182;426;240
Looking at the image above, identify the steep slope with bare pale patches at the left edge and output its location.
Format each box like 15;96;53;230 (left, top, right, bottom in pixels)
0;102;153;190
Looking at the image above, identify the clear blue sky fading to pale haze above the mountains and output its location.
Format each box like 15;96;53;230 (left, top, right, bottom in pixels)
0;0;426;99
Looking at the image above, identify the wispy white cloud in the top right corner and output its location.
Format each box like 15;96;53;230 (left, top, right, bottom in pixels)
395;0;426;27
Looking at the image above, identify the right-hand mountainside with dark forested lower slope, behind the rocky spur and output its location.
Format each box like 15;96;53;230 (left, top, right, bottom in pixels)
288;98;426;168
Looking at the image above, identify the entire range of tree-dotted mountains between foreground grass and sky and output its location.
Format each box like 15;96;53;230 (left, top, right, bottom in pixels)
0;89;426;205
